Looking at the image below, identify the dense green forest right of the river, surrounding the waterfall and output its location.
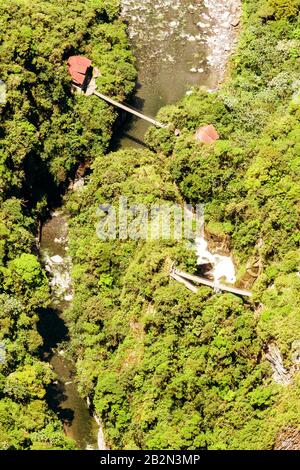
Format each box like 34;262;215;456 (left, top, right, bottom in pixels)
67;0;300;449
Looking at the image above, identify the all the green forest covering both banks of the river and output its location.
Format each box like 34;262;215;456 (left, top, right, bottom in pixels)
0;0;300;450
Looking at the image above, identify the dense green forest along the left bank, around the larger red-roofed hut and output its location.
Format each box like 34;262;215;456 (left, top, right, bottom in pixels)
0;0;136;449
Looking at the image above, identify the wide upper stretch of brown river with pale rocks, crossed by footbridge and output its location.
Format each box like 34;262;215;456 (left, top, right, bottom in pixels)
119;0;240;148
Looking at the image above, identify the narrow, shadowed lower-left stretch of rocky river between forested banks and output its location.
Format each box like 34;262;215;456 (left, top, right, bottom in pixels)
39;211;98;450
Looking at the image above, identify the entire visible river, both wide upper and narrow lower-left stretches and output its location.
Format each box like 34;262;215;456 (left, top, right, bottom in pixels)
40;0;240;450
